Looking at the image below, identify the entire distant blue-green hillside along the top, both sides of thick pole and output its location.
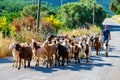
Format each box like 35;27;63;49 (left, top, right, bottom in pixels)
0;0;113;15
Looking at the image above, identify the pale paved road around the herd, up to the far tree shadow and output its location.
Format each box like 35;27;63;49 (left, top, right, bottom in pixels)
0;31;120;80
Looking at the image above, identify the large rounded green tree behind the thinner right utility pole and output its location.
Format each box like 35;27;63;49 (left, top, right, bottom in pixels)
58;0;106;28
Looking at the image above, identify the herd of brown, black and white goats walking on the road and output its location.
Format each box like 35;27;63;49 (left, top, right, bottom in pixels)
9;34;108;69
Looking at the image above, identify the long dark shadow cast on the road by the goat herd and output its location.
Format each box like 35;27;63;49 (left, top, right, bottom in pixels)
30;56;112;73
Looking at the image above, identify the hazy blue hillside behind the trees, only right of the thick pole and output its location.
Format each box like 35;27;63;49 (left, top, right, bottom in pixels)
42;0;113;15
